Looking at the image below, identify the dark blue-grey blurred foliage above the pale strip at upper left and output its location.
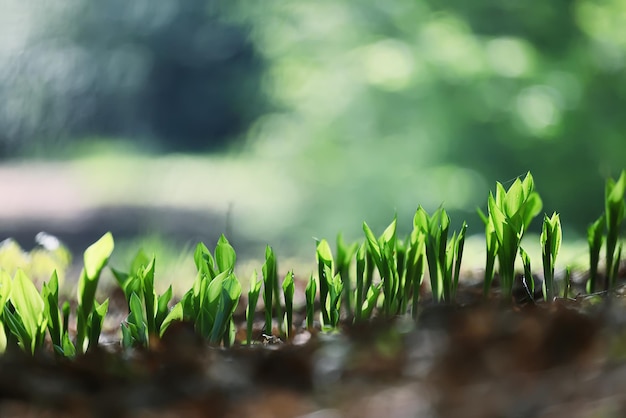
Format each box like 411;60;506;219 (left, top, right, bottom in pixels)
0;0;266;158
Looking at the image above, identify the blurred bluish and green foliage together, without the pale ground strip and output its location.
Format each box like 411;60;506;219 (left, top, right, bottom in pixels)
0;0;626;245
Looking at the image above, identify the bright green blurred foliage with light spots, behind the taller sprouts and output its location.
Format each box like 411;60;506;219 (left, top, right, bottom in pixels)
230;0;626;237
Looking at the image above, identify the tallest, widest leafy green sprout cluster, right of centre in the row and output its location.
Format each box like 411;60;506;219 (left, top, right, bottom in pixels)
487;173;542;300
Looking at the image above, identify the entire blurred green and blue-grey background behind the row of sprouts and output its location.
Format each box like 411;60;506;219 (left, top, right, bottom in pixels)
0;0;626;272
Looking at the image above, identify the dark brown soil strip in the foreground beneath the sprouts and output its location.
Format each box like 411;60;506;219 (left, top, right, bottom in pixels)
0;287;626;418
